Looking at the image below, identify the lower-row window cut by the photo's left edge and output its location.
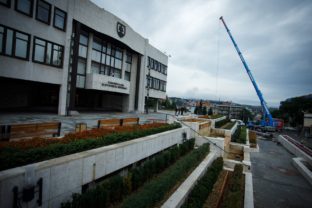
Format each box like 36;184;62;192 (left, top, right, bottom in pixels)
0;25;30;60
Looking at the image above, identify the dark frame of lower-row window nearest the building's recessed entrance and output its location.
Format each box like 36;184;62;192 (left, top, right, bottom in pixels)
32;36;65;68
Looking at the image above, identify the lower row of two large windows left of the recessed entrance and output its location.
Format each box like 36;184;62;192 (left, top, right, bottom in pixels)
0;25;64;67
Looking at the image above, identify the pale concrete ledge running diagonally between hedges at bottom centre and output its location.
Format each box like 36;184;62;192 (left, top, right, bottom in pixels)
161;151;217;208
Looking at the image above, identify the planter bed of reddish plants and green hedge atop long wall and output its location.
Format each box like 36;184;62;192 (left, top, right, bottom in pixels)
0;123;181;170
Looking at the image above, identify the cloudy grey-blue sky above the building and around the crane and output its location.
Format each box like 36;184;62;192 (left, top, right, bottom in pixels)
92;0;312;106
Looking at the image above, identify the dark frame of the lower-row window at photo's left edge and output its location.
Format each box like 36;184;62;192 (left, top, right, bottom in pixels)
0;24;31;61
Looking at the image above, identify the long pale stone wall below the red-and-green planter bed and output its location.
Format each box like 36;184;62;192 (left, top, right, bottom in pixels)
0;127;190;208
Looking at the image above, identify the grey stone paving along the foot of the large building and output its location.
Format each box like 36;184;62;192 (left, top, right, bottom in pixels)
0;111;180;135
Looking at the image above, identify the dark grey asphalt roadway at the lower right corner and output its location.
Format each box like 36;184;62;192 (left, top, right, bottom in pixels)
251;139;312;208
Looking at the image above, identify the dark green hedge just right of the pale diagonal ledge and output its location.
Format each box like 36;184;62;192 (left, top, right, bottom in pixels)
182;157;223;208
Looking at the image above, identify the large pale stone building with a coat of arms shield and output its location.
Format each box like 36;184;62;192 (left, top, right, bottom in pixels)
0;0;168;115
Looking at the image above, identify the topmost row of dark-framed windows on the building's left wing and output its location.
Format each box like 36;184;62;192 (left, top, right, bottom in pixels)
0;0;67;31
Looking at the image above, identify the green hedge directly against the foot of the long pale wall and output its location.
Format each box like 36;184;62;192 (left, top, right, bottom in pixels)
62;139;195;208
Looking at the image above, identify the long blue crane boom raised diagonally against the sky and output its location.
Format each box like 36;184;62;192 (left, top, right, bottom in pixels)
220;16;274;126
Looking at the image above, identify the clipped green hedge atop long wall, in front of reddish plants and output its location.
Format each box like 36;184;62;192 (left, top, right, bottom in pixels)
0;123;181;171
